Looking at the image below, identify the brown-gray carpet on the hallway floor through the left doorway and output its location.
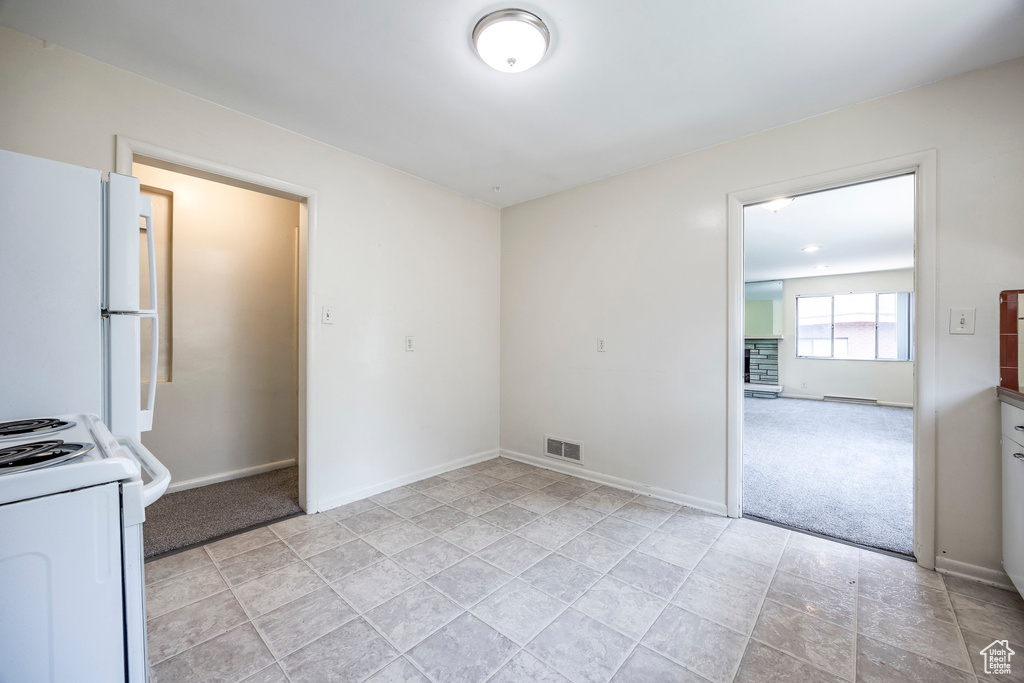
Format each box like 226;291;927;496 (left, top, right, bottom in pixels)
142;467;302;558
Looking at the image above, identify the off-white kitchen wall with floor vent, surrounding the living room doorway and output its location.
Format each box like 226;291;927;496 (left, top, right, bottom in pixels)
501;59;1024;570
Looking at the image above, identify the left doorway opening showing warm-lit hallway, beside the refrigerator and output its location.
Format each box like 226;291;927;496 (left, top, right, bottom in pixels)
131;156;303;558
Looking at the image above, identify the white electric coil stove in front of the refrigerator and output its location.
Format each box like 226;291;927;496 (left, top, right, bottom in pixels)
0;415;170;683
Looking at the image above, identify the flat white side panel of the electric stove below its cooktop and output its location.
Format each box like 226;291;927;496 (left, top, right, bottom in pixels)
0;482;125;683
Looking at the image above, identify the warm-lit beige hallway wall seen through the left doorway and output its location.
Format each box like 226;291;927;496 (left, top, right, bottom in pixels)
132;164;299;484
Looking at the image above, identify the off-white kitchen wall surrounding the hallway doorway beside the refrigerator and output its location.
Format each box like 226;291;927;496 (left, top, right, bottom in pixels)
0;28;500;505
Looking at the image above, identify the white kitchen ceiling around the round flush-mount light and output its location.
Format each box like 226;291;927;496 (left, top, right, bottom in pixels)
0;0;1024;206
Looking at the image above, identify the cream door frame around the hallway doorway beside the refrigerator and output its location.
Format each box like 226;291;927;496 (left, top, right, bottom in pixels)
114;135;319;513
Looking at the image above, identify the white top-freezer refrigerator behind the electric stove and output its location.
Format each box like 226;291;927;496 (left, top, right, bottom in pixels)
0;151;160;439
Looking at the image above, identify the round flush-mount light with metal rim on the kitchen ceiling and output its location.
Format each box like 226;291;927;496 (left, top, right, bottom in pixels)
473;9;551;74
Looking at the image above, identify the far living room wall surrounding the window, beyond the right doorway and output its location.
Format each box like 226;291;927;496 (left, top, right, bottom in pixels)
778;269;913;407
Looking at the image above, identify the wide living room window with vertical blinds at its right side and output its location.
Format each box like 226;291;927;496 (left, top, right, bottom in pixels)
797;292;913;360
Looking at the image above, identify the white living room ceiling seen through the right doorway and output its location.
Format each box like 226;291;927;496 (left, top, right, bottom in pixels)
743;175;914;283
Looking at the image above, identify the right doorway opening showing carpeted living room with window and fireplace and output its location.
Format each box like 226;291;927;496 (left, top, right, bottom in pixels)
741;173;916;556
